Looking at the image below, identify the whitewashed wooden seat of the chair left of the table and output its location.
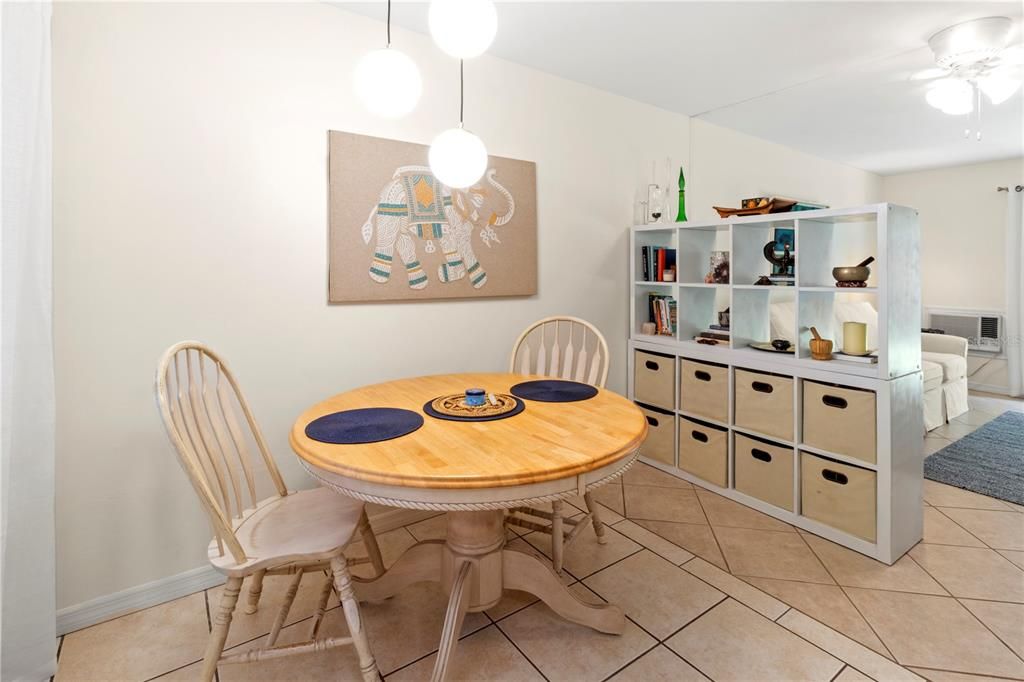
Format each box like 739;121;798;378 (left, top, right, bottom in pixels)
208;487;362;576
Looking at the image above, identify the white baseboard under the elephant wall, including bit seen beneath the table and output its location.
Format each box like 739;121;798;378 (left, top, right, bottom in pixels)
57;501;437;635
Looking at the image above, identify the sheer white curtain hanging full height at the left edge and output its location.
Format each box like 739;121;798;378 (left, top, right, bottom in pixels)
0;2;56;682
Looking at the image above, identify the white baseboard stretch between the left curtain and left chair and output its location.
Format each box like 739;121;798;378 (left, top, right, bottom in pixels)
57;565;224;635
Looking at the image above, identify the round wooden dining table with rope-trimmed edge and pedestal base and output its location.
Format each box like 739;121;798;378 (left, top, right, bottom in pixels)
291;374;647;680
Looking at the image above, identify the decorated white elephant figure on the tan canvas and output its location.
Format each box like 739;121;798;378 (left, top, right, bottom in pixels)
360;166;515;289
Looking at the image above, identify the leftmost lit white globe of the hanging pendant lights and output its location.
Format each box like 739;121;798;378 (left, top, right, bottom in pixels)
352;47;423;119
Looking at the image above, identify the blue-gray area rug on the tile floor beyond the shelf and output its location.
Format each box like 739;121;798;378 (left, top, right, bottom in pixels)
925;412;1024;505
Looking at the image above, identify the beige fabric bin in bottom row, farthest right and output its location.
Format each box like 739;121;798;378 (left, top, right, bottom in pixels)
800;453;876;543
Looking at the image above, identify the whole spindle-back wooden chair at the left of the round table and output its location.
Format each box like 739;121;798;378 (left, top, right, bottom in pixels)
157;341;384;682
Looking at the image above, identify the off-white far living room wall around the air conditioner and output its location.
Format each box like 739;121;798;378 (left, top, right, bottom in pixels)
882;153;1024;391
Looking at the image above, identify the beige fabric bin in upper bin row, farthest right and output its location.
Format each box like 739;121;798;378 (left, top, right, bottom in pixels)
803;381;876;464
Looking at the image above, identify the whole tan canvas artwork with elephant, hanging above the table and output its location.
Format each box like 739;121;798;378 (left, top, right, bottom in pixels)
328;131;537;303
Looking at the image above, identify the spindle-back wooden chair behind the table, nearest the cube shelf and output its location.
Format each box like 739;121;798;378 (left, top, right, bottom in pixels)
506;316;609;574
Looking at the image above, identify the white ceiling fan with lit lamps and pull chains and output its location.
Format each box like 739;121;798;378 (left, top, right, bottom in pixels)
910;16;1024;140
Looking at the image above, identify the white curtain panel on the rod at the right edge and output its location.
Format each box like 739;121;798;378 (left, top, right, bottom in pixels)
1005;184;1024;395
